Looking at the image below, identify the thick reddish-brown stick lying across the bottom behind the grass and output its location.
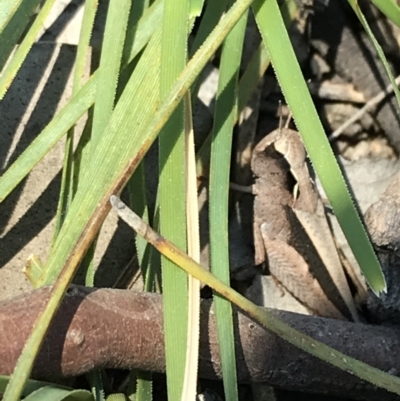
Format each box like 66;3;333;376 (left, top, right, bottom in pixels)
0;286;400;400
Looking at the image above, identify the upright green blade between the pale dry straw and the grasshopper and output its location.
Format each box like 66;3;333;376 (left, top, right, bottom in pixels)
209;6;247;400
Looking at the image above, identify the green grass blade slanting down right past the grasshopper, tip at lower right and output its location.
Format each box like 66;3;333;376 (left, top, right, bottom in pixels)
253;0;386;294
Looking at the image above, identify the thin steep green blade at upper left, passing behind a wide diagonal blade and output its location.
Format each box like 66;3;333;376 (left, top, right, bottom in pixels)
52;0;98;244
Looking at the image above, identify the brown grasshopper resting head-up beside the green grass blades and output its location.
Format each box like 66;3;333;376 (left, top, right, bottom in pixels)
251;117;358;320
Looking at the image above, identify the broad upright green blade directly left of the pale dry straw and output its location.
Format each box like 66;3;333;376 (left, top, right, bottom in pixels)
159;0;190;400
